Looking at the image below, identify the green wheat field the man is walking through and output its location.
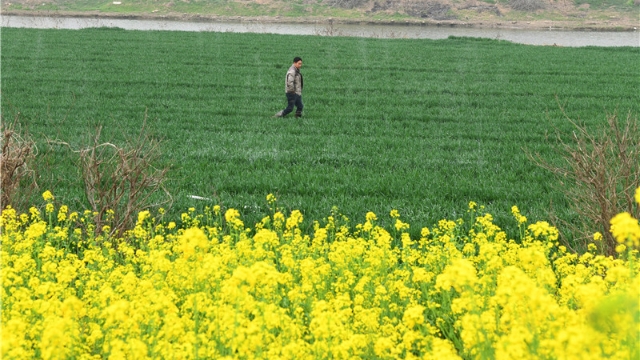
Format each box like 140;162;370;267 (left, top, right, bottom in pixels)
1;28;640;236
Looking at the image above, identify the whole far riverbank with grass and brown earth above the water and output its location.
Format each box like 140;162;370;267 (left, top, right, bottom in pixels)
2;0;640;30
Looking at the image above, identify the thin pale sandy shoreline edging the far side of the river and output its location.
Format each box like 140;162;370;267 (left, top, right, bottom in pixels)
2;10;639;32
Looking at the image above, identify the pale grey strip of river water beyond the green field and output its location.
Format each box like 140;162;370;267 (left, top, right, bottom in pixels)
2;16;640;47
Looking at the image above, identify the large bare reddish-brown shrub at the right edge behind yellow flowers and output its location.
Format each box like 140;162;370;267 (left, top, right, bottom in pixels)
530;110;640;255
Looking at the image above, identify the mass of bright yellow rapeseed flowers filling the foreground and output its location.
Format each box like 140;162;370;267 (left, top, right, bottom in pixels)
0;193;640;359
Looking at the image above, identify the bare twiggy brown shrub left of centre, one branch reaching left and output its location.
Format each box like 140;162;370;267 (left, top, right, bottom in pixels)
53;115;171;235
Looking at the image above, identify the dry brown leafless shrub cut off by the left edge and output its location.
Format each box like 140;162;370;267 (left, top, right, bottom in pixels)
0;113;37;211
